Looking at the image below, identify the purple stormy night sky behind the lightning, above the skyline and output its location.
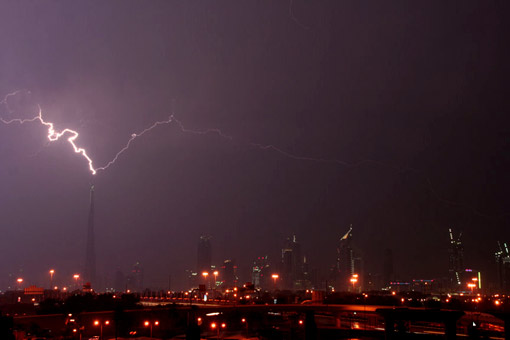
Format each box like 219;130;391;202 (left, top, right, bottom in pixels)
0;0;510;289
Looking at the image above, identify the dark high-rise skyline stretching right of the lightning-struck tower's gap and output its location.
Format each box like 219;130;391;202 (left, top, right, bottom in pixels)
179;225;510;294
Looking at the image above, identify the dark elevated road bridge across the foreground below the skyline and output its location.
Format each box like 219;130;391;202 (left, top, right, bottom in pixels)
14;301;510;340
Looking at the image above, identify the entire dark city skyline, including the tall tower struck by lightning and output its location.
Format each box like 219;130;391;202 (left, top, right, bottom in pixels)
2;220;510;299
